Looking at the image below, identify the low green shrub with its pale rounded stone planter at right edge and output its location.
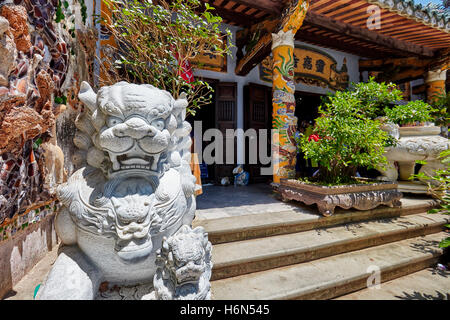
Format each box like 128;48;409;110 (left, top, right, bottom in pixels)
377;100;449;185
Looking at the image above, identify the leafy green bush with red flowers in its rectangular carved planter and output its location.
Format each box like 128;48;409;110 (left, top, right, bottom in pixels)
279;84;402;216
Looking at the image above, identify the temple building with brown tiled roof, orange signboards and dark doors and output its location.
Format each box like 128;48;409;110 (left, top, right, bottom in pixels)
187;0;450;185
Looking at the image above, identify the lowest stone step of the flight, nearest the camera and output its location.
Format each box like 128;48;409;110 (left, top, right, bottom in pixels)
212;232;448;300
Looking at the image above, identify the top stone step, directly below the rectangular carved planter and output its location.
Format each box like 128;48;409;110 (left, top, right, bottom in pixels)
193;198;436;244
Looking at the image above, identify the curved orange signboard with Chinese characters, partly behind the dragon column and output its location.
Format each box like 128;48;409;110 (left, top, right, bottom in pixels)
259;45;349;90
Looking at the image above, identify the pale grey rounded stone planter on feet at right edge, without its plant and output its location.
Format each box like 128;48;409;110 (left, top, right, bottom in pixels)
378;124;450;188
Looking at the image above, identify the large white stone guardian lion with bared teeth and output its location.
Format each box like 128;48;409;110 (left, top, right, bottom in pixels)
37;82;211;299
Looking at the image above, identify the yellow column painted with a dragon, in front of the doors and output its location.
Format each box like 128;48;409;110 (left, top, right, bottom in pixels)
272;0;309;183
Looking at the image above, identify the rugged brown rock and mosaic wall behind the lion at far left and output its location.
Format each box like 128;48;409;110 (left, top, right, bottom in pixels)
0;0;95;240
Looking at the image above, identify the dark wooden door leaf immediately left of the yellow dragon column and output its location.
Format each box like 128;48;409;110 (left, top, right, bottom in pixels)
244;83;272;183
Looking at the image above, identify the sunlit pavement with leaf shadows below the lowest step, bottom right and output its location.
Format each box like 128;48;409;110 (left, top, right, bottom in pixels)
336;268;450;300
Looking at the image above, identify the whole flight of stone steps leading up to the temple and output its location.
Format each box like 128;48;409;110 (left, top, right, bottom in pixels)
194;199;449;300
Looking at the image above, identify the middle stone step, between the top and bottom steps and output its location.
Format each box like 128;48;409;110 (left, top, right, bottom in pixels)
212;213;450;280
